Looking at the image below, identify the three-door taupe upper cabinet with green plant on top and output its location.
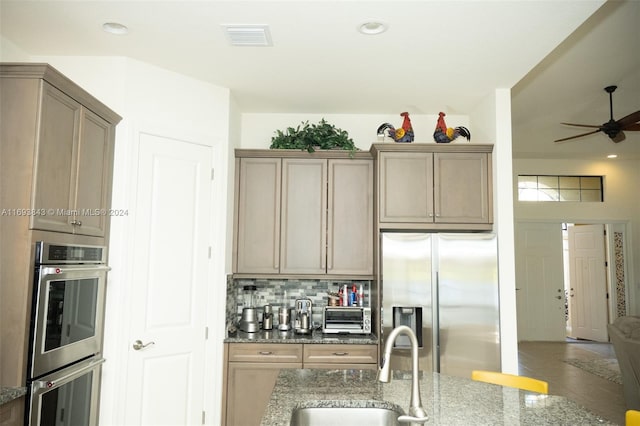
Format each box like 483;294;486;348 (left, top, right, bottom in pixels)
234;150;373;277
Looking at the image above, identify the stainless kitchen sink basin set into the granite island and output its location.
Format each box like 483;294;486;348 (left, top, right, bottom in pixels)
289;406;404;426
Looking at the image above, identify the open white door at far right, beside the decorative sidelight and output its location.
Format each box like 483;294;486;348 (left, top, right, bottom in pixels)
568;225;608;342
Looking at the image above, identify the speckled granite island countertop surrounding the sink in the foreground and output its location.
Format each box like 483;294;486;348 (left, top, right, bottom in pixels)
261;369;612;426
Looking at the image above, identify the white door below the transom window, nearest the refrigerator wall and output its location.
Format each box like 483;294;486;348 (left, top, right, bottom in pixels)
515;223;566;341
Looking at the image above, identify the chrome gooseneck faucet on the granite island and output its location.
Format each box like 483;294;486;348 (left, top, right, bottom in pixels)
378;325;429;423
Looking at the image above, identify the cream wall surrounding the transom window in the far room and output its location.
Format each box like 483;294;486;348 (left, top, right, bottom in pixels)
513;159;640;315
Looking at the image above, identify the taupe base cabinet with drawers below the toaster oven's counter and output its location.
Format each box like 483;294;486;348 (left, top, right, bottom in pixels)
222;343;378;426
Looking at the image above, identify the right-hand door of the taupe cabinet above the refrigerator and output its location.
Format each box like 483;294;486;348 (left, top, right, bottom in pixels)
433;152;491;223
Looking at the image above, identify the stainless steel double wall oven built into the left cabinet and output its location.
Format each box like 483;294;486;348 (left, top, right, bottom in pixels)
25;241;109;426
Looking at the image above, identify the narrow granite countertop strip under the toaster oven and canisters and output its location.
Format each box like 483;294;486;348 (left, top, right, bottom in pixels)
224;329;378;345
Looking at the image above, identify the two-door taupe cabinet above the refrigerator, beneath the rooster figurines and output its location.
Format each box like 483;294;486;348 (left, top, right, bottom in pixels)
372;144;493;230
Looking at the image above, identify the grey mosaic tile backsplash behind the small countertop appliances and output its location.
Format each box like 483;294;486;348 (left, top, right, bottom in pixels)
226;275;371;330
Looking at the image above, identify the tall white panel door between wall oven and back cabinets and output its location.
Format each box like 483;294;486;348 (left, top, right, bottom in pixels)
125;134;212;425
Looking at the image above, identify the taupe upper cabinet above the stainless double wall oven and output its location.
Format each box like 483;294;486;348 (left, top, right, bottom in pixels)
0;64;121;237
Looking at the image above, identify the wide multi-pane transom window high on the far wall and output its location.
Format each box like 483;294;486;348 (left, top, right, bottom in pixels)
518;175;604;203
